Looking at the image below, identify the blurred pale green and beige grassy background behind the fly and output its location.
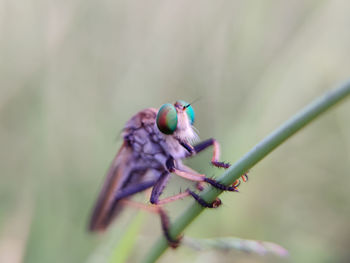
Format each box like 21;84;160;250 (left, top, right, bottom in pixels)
0;0;350;263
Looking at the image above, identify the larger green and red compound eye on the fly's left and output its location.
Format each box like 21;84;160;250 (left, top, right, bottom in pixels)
157;103;177;134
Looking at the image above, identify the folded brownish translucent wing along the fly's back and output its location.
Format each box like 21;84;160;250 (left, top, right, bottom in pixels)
89;143;131;231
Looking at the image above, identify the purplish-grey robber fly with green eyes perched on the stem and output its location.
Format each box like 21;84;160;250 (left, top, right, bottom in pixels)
89;100;247;247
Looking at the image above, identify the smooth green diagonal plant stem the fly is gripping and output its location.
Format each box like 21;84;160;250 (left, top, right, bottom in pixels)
144;81;350;263
